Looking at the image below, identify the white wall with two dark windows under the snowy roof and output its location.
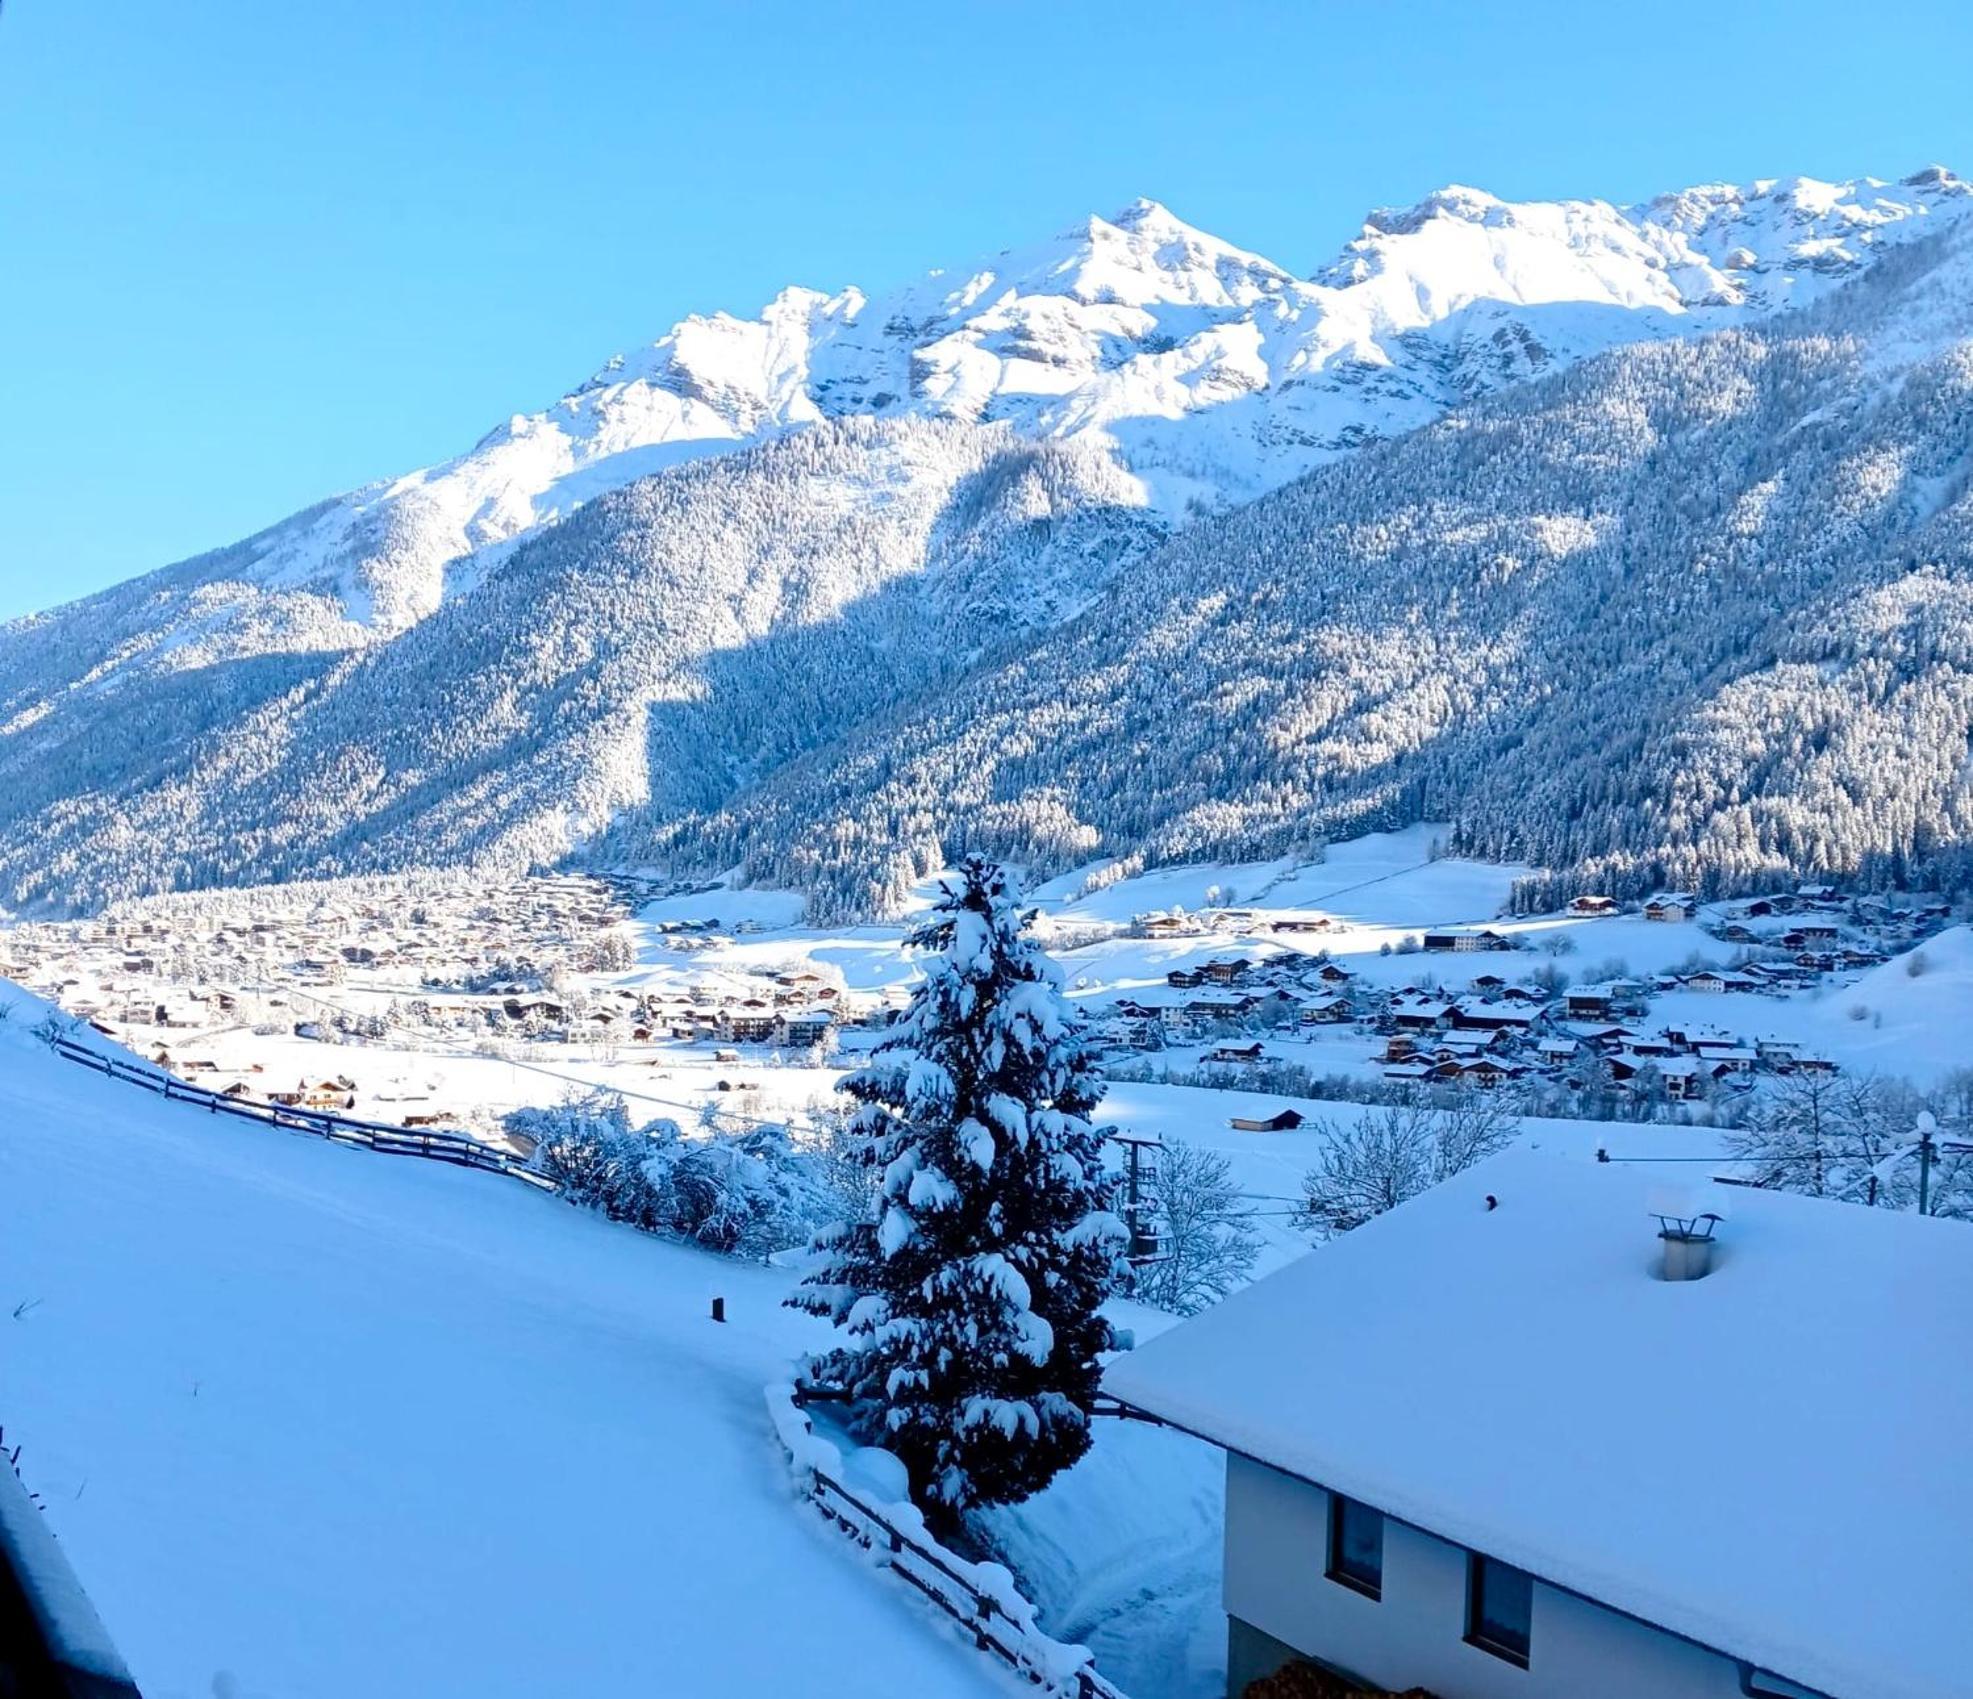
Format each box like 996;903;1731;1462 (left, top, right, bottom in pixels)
1225;1454;1740;1699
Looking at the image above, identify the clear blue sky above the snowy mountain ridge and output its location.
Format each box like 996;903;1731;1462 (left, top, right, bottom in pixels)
0;0;1973;618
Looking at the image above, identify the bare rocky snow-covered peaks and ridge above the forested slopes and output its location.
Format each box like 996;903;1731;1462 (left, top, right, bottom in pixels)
61;168;1973;655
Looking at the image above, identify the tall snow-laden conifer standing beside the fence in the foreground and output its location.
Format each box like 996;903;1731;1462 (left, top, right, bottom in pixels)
789;856;1127;1514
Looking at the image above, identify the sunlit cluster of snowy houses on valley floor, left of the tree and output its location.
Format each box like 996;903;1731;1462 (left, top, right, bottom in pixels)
0;874;894;1125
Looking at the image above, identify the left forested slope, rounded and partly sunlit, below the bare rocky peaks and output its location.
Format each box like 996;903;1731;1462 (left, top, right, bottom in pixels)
0;420;1160;904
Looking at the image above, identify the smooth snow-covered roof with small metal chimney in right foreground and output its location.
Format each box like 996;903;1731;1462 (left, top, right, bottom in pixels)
1105;1150;1973;1699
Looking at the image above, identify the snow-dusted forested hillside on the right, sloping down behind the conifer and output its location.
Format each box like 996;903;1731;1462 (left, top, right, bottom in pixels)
643;229;1973;910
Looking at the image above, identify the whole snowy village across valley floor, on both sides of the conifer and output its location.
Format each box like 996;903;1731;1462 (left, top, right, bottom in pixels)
0;827;1963;1156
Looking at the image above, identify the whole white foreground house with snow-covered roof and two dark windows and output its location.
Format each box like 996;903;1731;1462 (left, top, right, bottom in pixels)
1103;1150;1973;1699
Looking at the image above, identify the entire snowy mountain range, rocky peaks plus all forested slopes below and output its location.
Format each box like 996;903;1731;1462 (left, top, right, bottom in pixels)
0;168;1973;918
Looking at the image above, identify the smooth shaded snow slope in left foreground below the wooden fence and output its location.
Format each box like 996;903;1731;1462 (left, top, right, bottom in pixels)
0;998;1010;1699
